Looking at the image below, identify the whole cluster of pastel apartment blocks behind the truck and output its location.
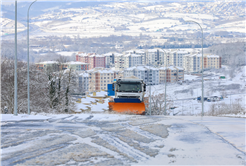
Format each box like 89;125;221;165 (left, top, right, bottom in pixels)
36;49;221;92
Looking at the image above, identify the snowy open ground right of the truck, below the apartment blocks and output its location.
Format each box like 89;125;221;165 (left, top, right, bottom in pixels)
146;66;246;117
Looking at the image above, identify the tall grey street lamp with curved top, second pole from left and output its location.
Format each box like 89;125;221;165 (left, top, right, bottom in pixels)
27;0;37;115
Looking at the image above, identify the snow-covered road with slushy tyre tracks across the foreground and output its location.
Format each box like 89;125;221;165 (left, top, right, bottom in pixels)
1;114;246;166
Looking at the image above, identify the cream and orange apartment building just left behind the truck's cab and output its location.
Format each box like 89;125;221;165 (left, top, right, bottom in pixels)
88;68;123;92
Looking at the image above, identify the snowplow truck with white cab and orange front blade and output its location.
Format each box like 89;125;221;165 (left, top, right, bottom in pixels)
108;78;146;115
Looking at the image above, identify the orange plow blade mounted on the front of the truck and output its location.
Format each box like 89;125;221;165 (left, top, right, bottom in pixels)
108;102;145;115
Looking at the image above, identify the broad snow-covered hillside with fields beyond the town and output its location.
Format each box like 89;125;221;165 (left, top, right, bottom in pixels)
2;2;245;38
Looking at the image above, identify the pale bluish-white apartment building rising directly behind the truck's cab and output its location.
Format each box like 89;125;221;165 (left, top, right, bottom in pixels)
124;65;159;85
